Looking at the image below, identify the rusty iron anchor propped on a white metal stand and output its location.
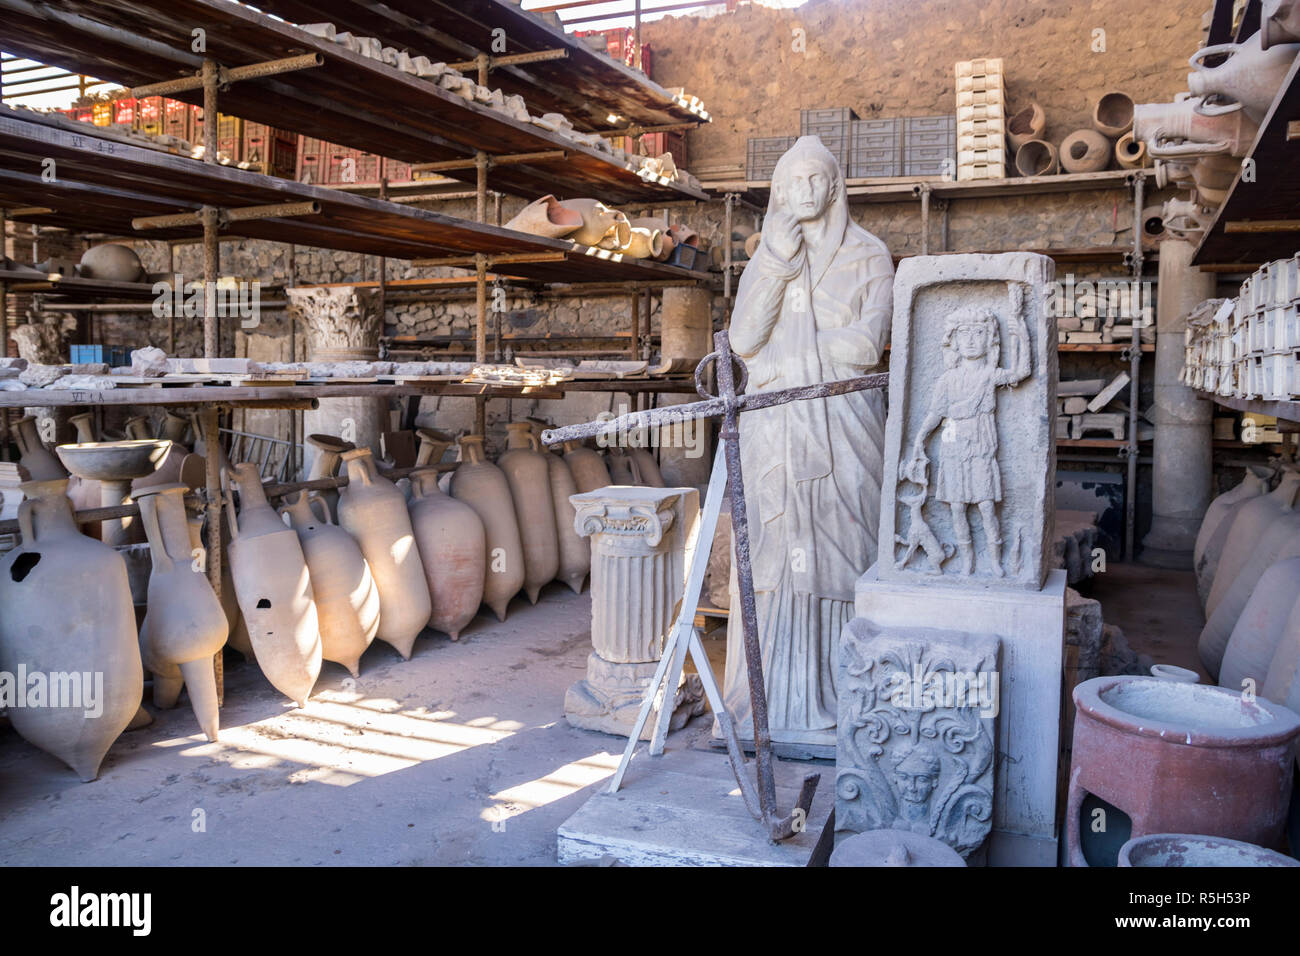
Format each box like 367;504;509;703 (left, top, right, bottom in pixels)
542;330;889;842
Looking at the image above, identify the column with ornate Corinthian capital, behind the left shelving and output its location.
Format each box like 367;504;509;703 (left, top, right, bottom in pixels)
285;286;389;475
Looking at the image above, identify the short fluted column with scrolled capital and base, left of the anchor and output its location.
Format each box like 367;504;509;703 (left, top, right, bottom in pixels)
564;485;705;739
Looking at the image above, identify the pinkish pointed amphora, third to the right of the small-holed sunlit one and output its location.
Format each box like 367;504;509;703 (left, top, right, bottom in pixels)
411;468;488;641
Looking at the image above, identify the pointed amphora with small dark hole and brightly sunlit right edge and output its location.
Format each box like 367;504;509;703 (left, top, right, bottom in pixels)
224;463;321;706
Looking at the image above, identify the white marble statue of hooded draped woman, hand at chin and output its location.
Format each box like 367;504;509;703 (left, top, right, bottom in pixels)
724;137;893;745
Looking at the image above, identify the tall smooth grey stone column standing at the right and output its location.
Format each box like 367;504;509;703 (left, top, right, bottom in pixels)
1141;239;1214;570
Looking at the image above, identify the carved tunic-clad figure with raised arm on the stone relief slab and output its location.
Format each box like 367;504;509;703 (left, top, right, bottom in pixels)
900;285;1032;578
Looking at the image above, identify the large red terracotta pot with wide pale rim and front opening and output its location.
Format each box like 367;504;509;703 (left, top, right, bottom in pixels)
1066;676;1300;866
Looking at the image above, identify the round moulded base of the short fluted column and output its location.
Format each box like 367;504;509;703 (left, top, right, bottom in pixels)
564;652;705;740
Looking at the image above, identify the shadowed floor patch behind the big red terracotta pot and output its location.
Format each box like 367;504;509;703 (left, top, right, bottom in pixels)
1079;563;1213;683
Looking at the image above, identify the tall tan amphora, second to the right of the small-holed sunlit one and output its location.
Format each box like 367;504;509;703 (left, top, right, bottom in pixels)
338;449;433;659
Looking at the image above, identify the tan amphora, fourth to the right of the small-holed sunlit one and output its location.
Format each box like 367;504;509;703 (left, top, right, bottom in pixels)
451;434;524;620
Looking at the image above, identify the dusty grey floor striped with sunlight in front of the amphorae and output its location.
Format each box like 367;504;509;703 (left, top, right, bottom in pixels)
0;585;709;866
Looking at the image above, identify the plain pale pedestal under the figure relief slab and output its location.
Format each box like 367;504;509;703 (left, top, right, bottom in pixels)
855;567;1066;866
